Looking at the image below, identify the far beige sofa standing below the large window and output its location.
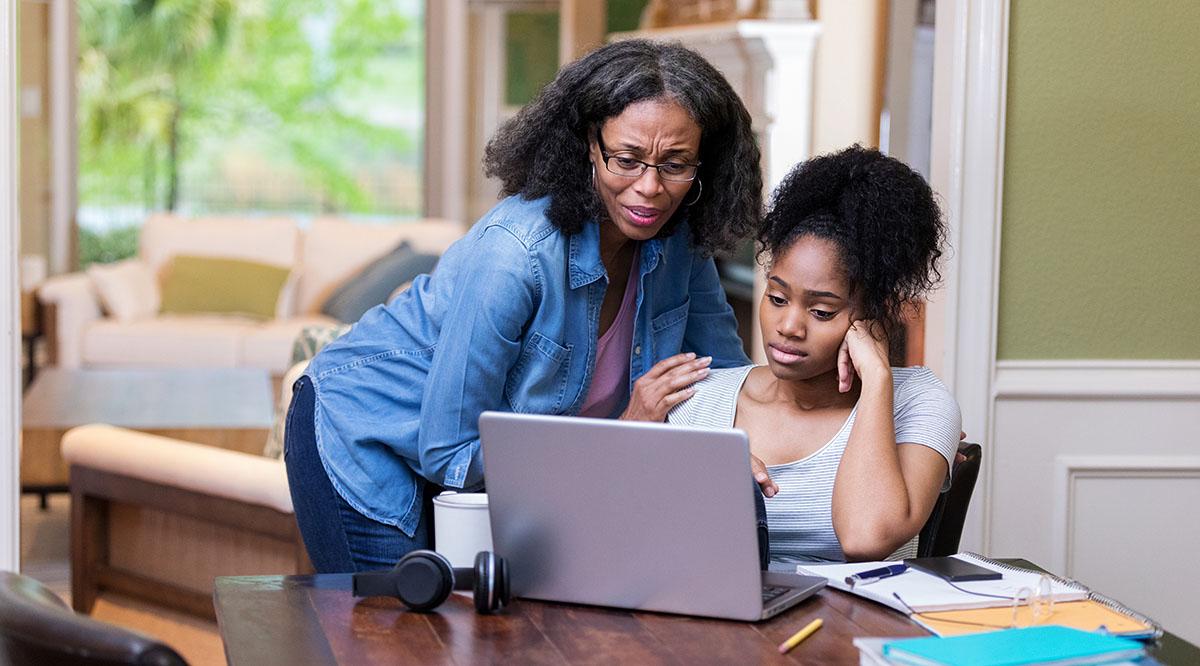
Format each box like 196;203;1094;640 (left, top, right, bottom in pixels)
38;215;466;376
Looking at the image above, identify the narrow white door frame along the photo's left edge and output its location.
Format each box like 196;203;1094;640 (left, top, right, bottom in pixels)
0;2;20;571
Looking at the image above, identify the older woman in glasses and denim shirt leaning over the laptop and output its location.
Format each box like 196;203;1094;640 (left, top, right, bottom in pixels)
286;41;762;571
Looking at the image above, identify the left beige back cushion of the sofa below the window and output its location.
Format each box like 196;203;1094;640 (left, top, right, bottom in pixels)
138;215;300;272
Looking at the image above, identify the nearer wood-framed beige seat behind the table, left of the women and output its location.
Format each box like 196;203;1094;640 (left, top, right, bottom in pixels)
62;361;313;619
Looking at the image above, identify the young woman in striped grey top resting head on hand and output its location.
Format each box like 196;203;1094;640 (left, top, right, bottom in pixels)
668;146;961;562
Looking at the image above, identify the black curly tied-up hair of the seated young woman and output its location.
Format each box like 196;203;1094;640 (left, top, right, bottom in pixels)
758;145;946;337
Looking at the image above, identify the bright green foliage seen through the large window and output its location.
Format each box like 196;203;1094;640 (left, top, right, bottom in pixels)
77;0;424;262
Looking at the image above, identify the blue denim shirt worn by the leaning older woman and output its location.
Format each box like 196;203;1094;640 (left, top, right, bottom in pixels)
306;197;749;535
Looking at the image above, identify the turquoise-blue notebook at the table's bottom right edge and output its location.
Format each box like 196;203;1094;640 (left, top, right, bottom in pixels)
883;625;1145;666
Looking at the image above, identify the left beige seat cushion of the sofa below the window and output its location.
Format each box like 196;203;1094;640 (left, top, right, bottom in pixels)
83;314;258;367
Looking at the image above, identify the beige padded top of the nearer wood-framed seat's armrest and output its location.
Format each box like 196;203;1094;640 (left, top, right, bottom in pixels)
62;424;293;514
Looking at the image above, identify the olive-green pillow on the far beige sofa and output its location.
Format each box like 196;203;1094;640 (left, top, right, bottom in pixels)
162;254;290;319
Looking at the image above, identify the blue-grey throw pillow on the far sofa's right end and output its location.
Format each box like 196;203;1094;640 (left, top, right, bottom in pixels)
320;241;438;323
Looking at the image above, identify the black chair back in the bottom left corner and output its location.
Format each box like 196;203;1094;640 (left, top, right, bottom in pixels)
0;571;187;666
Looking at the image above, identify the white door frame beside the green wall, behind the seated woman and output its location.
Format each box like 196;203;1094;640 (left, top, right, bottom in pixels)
925;0;1009;553
